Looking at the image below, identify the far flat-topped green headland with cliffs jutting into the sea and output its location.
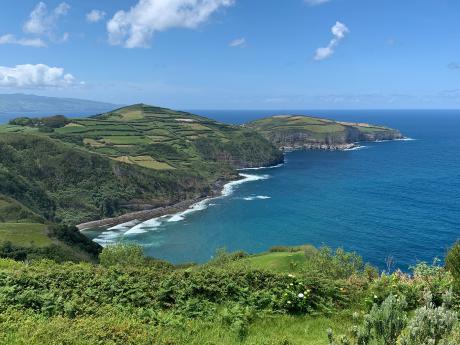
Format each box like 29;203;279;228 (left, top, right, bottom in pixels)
247;115;402;149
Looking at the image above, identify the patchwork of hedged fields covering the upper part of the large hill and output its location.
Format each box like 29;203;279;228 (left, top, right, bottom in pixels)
50;104;281;172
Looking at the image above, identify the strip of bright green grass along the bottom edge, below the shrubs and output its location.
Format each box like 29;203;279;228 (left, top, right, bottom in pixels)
0;310;350;345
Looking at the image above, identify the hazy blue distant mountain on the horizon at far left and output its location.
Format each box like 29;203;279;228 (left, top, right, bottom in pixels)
0;93;120;123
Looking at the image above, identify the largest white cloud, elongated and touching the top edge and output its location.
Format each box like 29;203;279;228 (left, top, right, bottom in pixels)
107;0;234;48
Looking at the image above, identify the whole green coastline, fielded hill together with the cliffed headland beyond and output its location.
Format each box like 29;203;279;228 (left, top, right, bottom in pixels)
0;104;402;257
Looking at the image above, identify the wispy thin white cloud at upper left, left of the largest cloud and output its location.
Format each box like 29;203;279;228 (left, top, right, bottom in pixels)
23;2;70;41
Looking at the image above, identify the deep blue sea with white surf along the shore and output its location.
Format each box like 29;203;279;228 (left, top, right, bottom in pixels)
83;110;460;270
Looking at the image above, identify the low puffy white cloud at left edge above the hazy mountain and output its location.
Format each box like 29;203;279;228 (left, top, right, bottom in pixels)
0;64;76;88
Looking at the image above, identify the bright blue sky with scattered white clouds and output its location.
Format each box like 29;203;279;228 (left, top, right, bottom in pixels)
0;0;460;109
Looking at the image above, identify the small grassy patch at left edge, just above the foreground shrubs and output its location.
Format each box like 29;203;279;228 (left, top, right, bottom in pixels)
0;223;52;247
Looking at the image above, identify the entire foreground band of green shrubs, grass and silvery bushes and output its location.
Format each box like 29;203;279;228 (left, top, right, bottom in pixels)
0;244;460;345
